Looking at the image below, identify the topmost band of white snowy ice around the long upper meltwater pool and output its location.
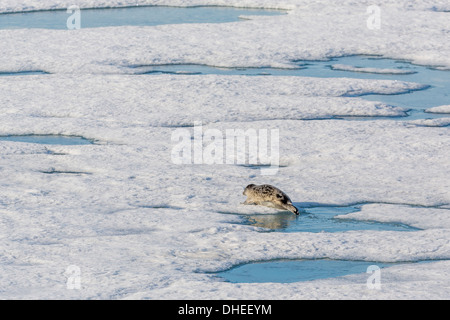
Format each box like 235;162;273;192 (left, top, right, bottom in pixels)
0;0;450;73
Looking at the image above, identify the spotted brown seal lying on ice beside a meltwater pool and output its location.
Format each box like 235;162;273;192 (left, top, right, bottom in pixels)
243;184;299;215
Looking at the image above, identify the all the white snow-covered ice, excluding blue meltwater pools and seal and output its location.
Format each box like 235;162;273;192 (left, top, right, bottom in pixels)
0;0;450;299
